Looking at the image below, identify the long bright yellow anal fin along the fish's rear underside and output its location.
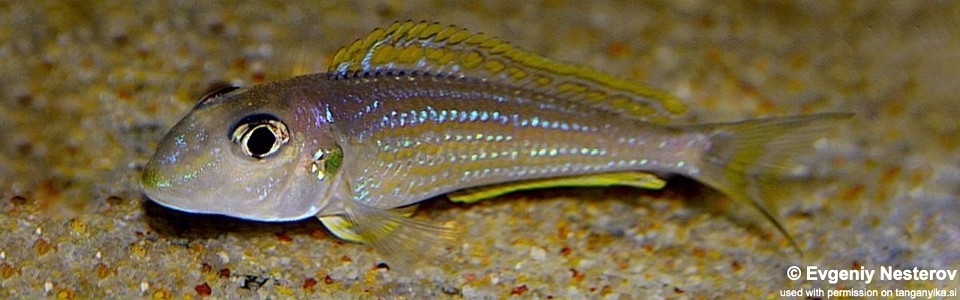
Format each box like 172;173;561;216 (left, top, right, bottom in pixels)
447;172;666;203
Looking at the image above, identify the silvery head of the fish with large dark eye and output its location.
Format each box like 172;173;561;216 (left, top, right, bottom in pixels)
141;86;342;221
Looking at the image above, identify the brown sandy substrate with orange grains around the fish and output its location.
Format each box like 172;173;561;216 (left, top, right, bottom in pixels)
0;1;960;299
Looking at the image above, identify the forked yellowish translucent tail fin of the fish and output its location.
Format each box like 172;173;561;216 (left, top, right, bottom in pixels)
697;113;853;255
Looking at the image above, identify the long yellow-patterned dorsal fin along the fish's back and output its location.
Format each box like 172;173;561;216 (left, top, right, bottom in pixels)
328;21;687;123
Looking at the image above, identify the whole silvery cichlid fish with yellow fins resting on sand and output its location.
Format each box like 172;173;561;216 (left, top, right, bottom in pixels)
141;22;851;260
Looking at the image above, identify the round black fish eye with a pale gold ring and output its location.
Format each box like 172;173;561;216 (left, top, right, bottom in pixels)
230;114;290;159
